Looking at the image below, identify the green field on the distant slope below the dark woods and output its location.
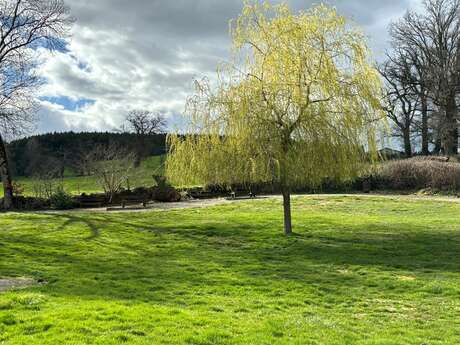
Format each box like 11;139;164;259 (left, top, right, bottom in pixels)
0;156;164;196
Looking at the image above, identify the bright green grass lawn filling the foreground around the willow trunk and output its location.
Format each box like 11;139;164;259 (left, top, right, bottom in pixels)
0;196;460;345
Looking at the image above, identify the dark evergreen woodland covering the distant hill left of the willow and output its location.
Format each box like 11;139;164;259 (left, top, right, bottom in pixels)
7;132;166;176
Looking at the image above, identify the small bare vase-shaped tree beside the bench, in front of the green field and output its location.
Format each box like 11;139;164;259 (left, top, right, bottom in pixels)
90;145;135;203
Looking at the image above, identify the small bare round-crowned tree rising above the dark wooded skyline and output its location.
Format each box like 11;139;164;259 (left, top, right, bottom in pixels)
126;110;166;166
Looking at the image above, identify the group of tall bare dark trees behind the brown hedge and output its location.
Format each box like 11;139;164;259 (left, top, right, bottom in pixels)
386;0;460;155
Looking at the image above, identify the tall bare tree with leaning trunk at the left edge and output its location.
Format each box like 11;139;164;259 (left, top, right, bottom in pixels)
0;0;73;209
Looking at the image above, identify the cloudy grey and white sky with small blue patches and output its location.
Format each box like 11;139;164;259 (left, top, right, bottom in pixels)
36;0;421;133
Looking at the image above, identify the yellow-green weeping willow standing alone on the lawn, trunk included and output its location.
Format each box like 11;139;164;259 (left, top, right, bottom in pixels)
166;3;383;234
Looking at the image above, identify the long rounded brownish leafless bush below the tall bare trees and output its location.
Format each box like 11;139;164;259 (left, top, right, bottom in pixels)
375;157;460;192
